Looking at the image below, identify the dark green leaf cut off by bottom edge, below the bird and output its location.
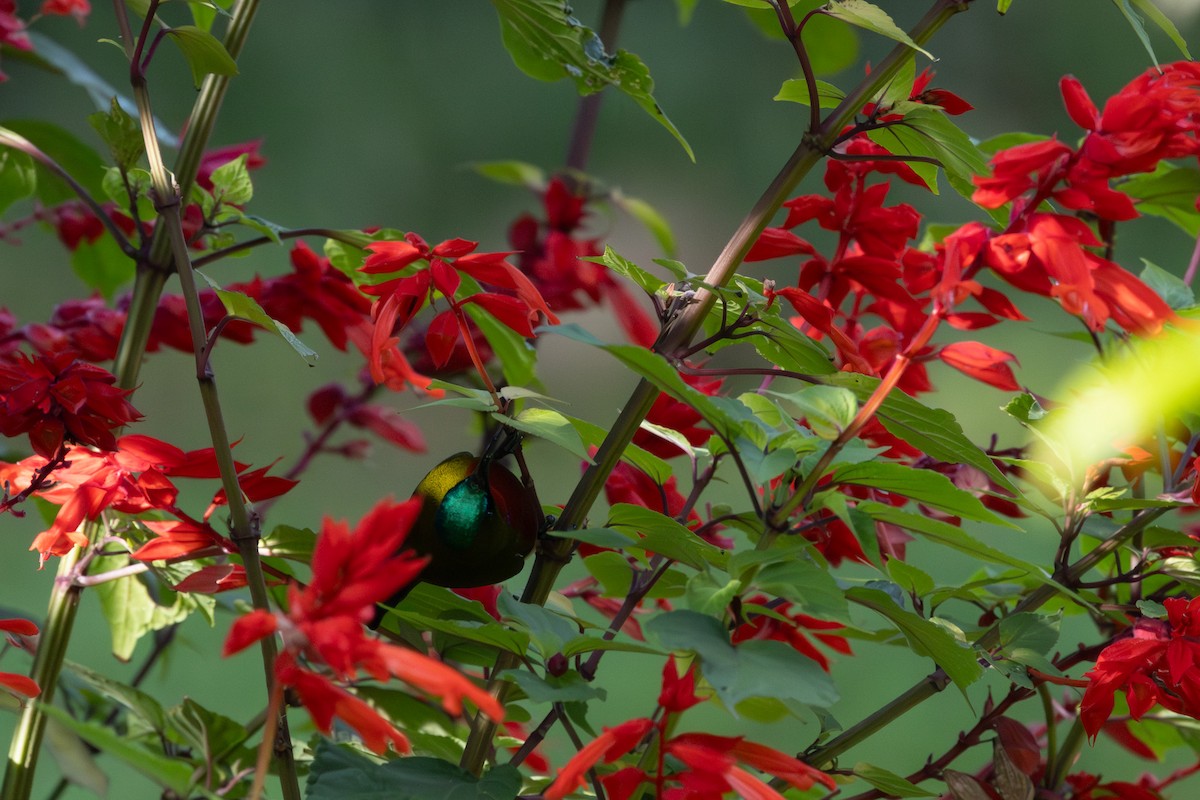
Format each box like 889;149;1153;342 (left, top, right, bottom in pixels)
305;739;521;800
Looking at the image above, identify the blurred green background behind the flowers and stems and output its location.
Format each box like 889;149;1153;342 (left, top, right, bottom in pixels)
0;0;1200;796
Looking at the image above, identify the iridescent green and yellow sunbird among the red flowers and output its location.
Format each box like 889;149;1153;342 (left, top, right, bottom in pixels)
370;428;542;628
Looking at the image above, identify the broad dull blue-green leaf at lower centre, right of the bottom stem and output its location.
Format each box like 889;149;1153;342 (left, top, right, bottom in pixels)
643;610;838;711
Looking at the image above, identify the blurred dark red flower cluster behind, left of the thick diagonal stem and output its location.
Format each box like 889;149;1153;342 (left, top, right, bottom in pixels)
509;176;659;347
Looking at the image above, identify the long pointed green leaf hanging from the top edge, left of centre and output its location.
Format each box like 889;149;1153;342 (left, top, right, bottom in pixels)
492;0;696;161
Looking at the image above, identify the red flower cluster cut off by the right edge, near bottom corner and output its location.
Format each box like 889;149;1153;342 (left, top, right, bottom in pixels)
1079;597;1200;739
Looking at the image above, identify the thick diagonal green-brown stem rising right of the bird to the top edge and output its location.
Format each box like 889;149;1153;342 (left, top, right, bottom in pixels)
461;0;970;775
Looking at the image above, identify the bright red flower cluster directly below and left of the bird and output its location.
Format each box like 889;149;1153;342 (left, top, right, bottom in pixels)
224;500;504;753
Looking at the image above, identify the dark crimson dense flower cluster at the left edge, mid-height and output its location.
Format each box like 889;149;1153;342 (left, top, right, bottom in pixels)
0;353;142;458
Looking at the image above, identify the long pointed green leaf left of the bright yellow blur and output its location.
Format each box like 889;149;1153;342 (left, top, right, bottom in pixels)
822;372;1027;496
